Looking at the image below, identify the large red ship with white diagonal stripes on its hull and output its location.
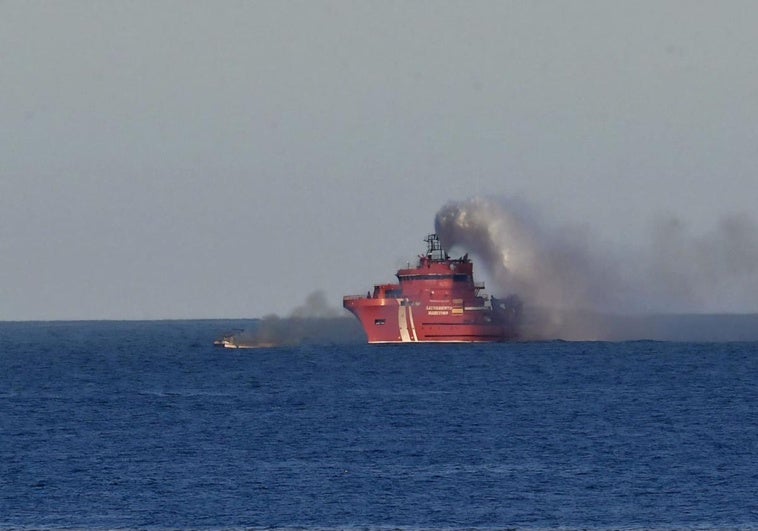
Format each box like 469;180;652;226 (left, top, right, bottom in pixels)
342;234;521;343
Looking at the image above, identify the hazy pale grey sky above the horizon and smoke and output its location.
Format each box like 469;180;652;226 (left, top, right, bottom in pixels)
0;0;758;320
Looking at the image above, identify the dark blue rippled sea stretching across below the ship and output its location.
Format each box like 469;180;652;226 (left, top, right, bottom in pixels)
0;322;758;528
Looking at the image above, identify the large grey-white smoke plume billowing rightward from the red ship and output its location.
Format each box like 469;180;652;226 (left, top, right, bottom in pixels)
435;198;758;339
